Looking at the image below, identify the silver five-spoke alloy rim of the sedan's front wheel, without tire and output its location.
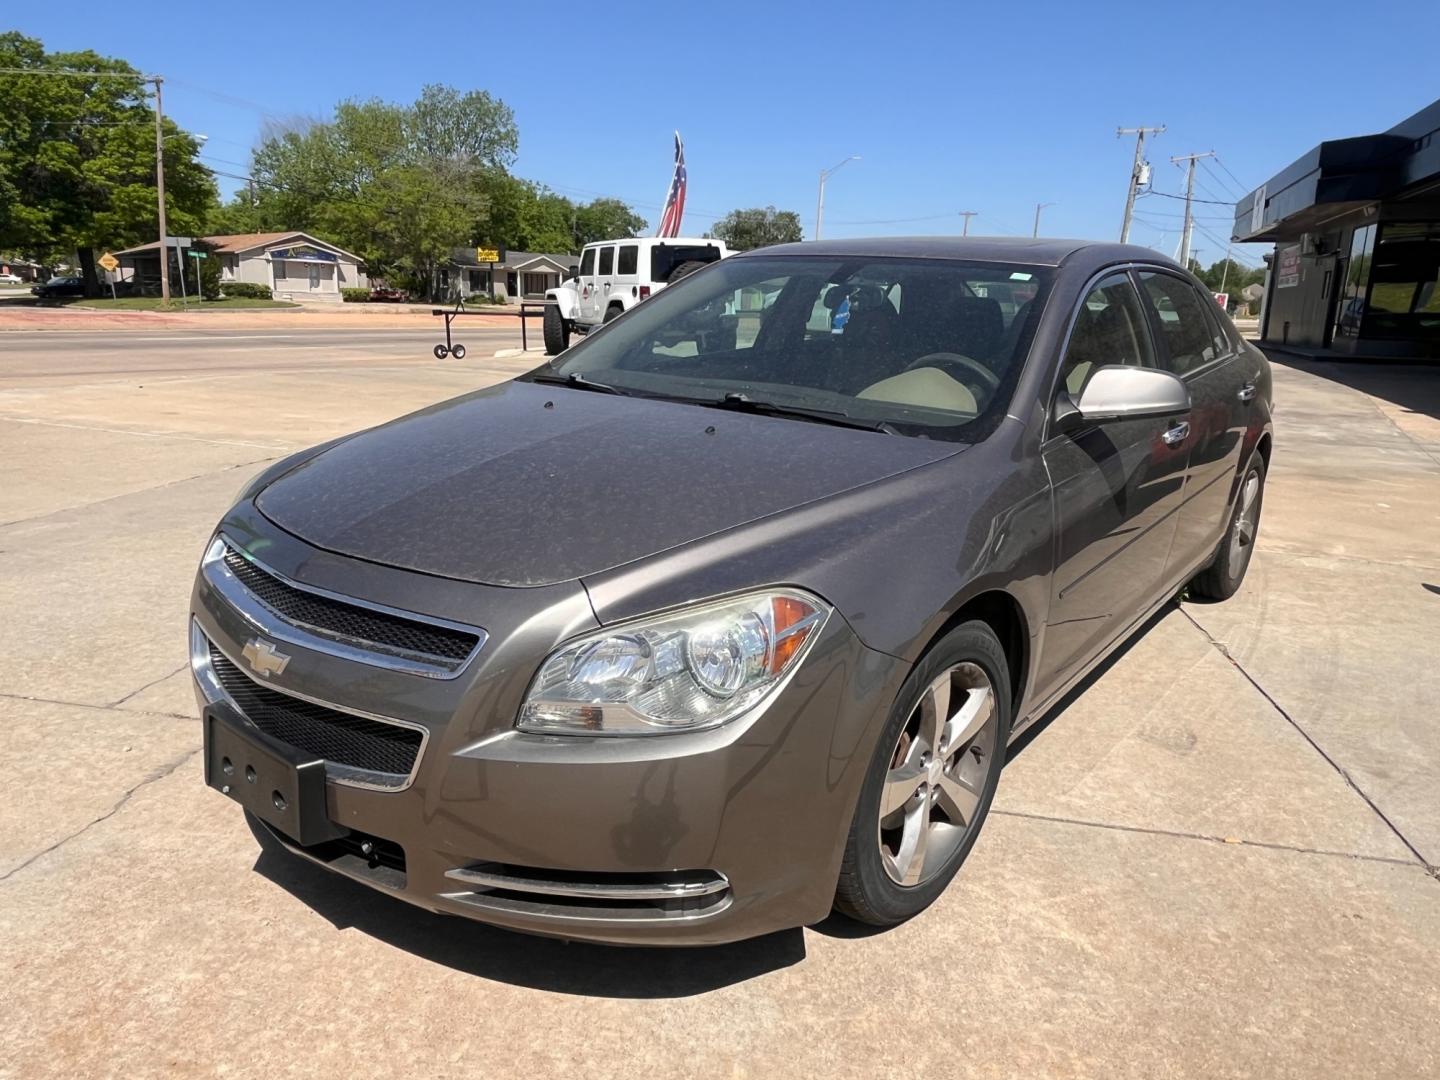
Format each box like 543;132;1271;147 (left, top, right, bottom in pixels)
878;661;999;887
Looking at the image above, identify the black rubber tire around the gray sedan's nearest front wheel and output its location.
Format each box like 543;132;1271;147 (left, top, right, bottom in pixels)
835;621;1011;926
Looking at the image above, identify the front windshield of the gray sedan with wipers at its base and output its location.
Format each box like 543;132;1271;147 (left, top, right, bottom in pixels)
531;255;1050;441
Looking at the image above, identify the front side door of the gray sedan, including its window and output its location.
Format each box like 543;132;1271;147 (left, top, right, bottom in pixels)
1040;272;1189;693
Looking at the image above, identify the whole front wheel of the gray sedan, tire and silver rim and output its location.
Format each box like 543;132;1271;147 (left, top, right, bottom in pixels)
835;622;1011;926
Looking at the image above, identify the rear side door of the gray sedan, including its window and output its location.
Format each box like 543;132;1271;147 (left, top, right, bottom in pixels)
1138;269;1247;577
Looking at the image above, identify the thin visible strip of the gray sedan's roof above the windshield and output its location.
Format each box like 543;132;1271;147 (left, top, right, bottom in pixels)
734;236;1178;266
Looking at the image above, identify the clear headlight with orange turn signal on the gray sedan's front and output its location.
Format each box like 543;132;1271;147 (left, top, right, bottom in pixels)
517;589;831;734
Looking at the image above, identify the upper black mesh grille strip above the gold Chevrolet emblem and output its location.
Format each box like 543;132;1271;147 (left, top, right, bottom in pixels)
225;544;480;667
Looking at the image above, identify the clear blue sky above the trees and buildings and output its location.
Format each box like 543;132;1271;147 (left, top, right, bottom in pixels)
10;0;1440;264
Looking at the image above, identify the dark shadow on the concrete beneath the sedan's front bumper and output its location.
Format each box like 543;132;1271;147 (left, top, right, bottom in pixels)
252;829;805;998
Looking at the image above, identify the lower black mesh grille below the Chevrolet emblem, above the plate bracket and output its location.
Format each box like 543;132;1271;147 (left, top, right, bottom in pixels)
210;645;425;788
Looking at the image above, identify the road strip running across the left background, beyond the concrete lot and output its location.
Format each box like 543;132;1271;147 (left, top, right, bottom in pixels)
0;320;539;382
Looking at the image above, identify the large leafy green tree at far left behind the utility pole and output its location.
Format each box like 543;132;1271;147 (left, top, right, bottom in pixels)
0;30;216;294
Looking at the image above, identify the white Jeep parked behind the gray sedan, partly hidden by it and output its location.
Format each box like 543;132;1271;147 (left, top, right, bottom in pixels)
544;236;730;356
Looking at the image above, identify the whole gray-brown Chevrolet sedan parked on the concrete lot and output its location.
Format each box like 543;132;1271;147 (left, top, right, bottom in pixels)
190;239;1272;945
